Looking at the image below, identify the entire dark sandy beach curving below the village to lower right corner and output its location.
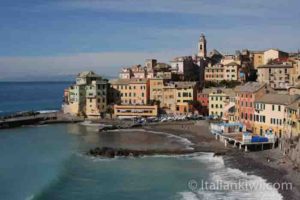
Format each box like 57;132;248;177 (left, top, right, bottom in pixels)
145;121;300;200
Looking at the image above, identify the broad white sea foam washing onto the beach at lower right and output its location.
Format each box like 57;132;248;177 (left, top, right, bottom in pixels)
178;153;283;200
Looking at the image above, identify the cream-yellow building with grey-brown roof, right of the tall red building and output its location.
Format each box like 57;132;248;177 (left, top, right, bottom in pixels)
254;94;298;137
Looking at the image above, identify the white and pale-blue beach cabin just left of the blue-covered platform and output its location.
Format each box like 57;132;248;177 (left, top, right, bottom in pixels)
210;122;246;135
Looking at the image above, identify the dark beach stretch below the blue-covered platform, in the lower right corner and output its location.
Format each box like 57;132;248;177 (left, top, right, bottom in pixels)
223;149;300;200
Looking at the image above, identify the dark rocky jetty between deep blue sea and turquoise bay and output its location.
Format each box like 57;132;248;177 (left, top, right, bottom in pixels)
0;111;84;129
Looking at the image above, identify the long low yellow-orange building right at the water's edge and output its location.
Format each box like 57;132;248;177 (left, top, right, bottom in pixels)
114;105;157;118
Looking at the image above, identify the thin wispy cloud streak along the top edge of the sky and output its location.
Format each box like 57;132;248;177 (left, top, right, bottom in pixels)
59;0;299;16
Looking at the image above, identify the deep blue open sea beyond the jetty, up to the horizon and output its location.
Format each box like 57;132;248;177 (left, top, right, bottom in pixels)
0;82;71;115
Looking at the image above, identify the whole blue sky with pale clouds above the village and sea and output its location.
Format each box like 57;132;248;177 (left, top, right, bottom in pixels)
0;0;300;81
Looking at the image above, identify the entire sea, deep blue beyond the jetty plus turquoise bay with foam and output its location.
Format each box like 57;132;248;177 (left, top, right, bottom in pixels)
0;82;282;200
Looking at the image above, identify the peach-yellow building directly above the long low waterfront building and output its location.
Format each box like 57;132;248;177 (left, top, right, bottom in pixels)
110;78;149;105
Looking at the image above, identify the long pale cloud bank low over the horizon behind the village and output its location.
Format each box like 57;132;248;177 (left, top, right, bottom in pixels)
0;50;191;80
